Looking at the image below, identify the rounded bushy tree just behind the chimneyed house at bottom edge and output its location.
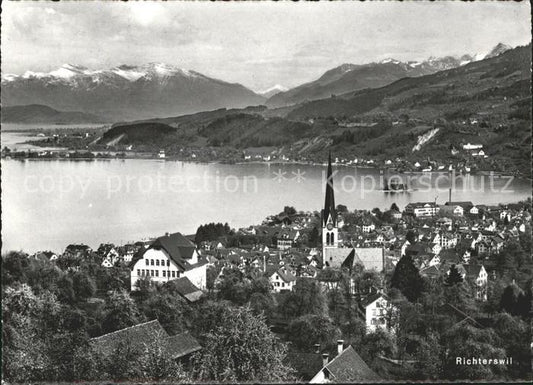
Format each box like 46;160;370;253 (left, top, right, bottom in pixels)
287;314;340;350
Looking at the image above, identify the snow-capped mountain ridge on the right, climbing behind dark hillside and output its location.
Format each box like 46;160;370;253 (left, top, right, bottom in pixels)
266;43;511;107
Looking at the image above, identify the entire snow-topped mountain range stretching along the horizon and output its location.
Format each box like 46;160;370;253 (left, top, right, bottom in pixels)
2;44;510;122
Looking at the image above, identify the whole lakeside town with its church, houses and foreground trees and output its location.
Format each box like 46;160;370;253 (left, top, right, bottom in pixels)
2;155;533;383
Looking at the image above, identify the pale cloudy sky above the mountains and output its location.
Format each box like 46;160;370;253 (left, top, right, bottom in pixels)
1;1;531;91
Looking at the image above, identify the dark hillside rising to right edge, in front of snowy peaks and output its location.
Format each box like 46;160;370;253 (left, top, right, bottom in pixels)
287;45;531;120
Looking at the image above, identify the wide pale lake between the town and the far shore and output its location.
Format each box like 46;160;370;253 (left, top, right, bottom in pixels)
1;159;531;252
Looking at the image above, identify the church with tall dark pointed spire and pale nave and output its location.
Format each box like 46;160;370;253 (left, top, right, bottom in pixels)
321;153;385;271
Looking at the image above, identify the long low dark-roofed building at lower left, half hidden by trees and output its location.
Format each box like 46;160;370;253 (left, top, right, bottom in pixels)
89;320;202;361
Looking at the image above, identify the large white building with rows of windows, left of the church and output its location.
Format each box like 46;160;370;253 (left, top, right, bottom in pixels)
130;233;207;291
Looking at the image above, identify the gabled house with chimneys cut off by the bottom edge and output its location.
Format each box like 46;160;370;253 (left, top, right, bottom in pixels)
309;340;381;384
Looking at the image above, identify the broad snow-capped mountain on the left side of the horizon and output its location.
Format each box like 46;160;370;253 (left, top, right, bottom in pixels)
2;63;265;120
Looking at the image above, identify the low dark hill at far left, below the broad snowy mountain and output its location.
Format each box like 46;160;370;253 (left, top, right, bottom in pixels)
1;104;104;124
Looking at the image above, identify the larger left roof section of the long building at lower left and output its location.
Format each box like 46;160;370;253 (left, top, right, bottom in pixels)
90;320;168;355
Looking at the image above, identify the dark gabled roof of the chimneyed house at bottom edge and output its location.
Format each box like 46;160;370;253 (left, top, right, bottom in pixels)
322;346;381;383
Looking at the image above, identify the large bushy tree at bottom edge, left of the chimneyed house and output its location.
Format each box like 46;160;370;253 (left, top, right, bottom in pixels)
192;307;291;382
